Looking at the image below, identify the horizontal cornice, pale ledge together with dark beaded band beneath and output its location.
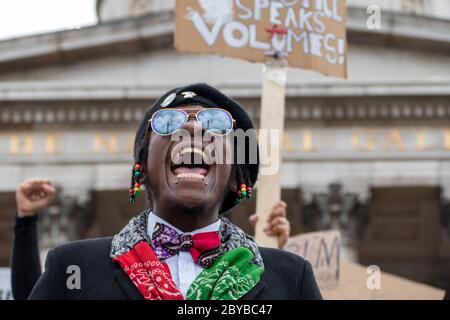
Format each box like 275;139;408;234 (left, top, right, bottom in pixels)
0;80;450;125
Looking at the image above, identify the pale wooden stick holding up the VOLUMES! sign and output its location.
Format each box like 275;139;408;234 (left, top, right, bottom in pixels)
255;59;287;248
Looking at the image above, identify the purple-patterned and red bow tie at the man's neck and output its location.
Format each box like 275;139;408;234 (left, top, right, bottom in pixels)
152;222;220;268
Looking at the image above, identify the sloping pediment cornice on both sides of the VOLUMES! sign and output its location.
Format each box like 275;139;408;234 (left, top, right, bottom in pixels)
0;7;450;71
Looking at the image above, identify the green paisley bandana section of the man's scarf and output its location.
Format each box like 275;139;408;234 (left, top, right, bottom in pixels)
186;247;264;300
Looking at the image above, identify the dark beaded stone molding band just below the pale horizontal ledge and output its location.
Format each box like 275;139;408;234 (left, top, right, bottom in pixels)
0;97;450;125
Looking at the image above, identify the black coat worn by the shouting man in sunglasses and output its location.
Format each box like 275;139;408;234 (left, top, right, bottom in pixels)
29;237;322;300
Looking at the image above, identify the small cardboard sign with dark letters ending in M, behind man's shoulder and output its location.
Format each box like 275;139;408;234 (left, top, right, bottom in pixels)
284;230;341;290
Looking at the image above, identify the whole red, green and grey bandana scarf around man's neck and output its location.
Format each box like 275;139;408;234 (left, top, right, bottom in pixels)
110;211;264;300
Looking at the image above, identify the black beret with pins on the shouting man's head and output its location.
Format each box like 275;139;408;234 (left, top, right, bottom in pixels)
134;83;259;213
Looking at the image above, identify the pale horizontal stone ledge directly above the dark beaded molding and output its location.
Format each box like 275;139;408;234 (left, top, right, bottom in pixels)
0;78;450;102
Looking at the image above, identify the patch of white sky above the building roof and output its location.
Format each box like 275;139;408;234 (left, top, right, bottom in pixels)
0;0;97;40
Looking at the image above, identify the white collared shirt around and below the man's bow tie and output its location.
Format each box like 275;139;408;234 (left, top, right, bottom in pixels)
147;212;221;297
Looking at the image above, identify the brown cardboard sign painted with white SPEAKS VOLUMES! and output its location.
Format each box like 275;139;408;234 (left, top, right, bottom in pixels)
175;0;347;78
